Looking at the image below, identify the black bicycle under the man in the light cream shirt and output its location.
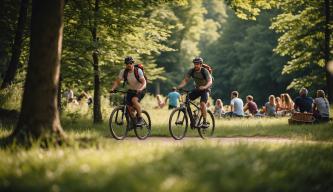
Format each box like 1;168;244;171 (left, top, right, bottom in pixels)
109;90;151;140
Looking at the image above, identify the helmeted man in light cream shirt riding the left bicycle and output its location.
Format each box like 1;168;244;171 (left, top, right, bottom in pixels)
110;56;147;126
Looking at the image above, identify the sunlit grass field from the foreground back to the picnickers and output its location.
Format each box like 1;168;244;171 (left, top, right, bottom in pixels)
0;106;333;192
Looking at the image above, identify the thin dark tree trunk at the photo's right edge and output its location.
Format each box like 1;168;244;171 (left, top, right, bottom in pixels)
324;0;333;103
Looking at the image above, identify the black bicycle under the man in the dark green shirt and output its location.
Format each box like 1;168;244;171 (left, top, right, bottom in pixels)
169;90;215;140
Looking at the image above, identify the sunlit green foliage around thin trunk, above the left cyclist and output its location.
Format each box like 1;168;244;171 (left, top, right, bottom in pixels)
62;0;181;94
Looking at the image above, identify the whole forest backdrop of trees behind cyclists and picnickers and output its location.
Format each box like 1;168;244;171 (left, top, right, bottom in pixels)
0;0;333;122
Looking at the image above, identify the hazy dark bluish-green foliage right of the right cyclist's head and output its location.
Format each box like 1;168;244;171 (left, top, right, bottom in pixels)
203;8;290;105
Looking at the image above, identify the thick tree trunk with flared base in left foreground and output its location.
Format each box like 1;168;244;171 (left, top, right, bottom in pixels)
11;0;64;144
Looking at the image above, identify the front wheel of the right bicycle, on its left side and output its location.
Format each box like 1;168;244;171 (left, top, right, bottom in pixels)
169;107;188;140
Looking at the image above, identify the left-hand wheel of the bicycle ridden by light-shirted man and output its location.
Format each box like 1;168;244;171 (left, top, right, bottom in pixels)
109;106;129;140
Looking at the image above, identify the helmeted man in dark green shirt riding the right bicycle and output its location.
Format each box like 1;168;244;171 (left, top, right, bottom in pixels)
177;57;213;128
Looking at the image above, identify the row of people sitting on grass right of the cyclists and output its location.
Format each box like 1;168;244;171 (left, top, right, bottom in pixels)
214;88;330;122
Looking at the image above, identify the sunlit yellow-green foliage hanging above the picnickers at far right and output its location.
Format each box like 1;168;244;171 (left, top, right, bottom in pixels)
271;0;333;89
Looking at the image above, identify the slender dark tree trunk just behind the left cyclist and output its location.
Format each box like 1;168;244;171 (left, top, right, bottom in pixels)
91;0;103;123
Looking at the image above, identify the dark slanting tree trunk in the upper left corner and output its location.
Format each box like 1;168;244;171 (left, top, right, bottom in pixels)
1;0;29;89
